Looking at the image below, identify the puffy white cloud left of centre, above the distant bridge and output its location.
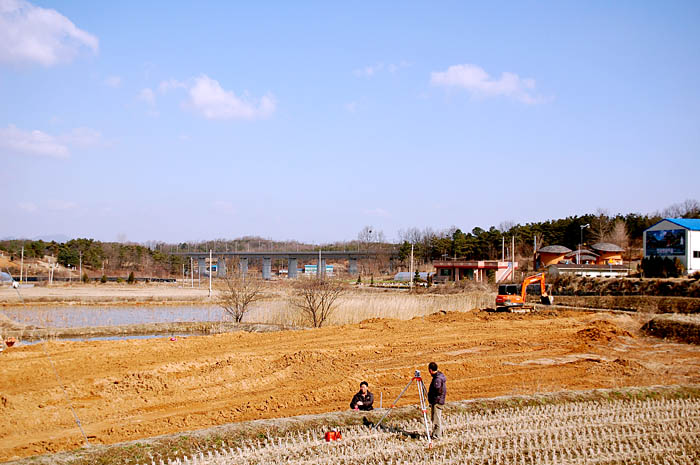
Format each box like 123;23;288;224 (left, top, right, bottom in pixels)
185;74;276;119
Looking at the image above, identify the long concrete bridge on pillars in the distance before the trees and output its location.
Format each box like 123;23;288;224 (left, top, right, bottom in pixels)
176;250;379;279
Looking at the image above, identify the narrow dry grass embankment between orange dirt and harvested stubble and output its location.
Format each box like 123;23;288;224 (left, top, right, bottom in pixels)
10;385;700;465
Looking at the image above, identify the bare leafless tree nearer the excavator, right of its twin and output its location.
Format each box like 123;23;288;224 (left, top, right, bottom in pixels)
289;279;347;328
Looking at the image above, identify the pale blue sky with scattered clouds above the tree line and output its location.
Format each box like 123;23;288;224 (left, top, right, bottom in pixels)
0;0;700;242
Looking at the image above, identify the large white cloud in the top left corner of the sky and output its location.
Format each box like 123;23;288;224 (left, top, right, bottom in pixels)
0;0;99;66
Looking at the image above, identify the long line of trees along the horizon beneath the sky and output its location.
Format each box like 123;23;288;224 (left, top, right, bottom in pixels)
0;200;700;276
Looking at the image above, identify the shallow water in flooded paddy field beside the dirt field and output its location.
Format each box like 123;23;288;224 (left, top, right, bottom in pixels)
0;305;226;328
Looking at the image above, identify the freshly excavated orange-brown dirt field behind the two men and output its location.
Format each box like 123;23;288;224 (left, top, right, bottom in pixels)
0;311;700;460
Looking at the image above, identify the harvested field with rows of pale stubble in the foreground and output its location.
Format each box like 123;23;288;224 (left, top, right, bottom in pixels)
130;399;700;465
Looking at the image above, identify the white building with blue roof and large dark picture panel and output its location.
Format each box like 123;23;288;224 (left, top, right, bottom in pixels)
644;218;700;274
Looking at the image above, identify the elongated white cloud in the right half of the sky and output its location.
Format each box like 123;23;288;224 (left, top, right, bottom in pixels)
430;64;542;104
